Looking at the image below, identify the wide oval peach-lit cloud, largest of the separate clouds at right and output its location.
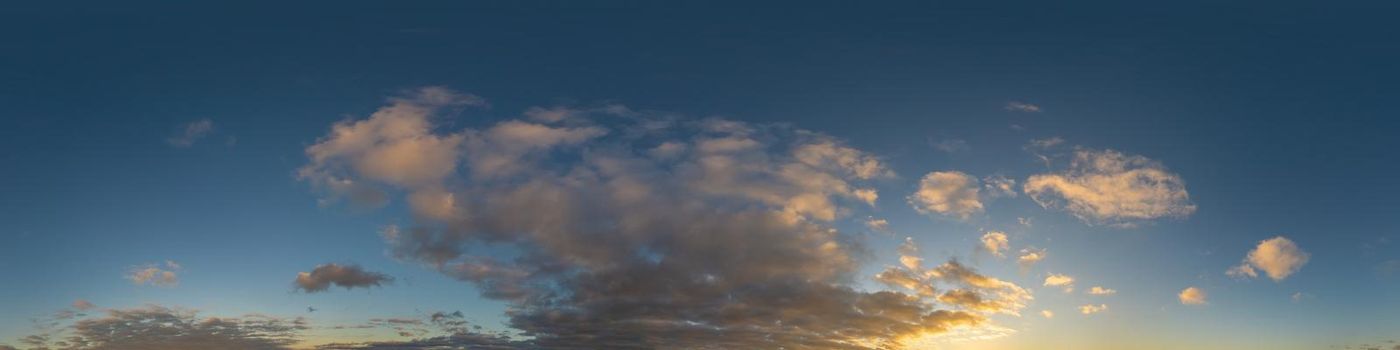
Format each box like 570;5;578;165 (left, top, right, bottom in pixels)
1023;150;1196;227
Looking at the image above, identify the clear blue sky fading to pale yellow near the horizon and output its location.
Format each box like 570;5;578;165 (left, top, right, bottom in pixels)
0;1;1400;349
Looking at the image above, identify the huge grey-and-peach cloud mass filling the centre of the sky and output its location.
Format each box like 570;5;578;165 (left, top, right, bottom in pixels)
300;88;1002;349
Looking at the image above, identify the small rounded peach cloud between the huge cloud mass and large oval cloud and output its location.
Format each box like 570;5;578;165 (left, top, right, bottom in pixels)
909;171;983;218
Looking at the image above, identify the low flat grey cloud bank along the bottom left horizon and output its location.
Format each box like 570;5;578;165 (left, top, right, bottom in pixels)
13;305;309;350
